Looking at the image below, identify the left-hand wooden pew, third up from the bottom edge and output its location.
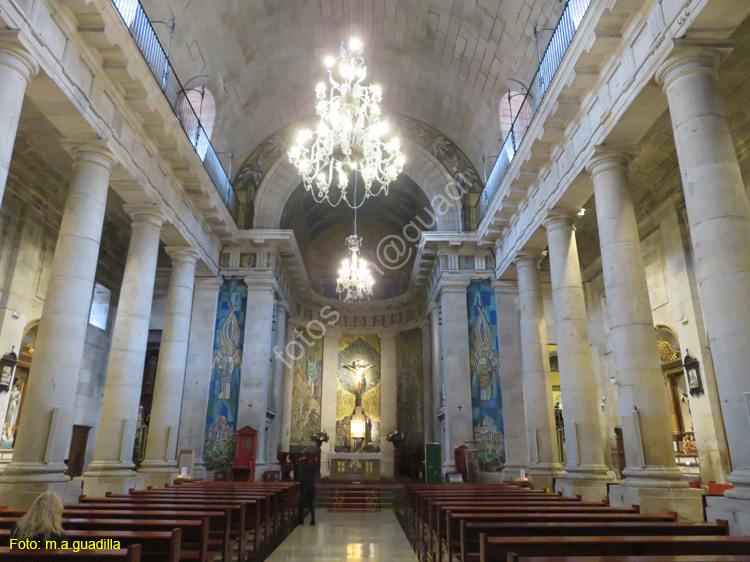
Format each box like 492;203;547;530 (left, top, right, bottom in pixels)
0;517;209;562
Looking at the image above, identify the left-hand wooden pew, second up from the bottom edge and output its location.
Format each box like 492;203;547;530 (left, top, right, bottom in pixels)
0;529;178;562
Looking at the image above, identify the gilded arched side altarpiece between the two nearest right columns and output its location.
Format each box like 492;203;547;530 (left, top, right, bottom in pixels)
655;325;699;472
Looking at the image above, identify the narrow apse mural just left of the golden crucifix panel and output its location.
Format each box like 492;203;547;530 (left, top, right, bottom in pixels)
289;338;323;452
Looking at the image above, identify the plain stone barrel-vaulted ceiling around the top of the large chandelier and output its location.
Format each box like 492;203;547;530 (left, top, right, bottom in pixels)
142;0;562;173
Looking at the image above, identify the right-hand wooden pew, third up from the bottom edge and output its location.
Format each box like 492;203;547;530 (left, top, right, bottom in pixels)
451;520;729;562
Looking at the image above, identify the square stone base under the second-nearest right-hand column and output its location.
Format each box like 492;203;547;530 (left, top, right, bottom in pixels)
609;482;703;521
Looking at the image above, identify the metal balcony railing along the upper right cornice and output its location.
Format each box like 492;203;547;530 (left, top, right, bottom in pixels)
476;0;591;228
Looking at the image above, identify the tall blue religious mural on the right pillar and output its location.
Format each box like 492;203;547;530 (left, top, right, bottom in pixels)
466;282;505;472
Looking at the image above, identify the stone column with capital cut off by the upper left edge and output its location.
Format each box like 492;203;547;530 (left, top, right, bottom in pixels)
0;41;39;208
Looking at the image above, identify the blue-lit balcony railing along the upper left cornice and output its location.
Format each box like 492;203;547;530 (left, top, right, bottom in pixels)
111;0;240;223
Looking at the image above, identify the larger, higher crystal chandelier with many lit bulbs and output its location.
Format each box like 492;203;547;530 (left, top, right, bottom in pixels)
288;38;405;208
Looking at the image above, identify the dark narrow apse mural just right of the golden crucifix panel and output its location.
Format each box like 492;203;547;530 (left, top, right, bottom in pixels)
396;328;424;449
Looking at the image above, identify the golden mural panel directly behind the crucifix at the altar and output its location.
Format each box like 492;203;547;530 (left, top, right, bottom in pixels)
334;335;380;452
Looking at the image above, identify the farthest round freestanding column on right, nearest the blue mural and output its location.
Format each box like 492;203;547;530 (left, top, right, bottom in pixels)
514;253;563;490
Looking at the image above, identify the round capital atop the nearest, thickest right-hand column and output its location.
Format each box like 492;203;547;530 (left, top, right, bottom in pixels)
654;39;733;92
